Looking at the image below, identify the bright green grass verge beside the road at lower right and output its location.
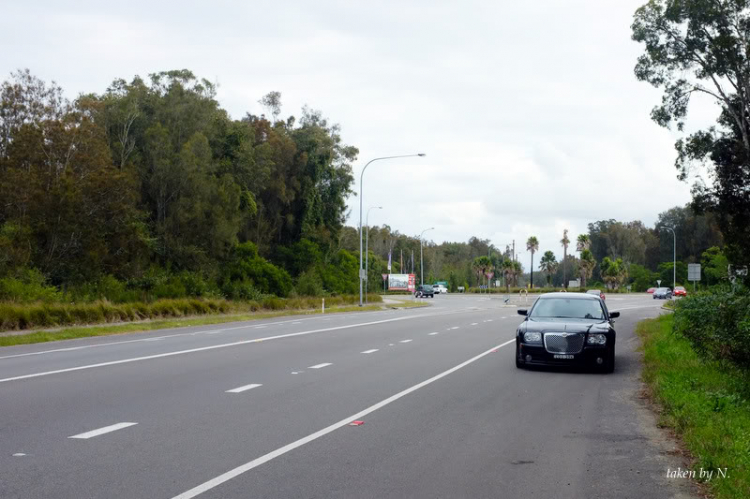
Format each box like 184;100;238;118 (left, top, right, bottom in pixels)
637;314;750;499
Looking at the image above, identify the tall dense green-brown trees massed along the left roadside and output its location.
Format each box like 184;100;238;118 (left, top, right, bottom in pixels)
0;70;358;302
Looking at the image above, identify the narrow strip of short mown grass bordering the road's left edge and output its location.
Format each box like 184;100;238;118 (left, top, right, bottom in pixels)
0;296;429;347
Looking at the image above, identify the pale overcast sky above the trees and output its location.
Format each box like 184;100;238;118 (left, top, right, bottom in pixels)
0;0;704;268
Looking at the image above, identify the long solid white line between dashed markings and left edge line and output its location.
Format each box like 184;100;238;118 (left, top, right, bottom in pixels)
0;315;438;383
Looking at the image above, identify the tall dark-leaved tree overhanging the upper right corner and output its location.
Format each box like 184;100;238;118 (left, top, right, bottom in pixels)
632;0;750;261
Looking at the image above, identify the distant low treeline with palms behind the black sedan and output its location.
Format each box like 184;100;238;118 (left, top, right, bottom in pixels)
352;205;731;292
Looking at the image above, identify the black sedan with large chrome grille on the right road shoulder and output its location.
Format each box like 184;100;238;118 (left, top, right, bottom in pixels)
516;293;620;373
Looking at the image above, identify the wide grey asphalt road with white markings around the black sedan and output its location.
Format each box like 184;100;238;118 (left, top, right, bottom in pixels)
0;295;690;499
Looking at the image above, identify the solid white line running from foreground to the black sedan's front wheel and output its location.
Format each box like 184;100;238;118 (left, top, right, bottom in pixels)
172;338;516;499
